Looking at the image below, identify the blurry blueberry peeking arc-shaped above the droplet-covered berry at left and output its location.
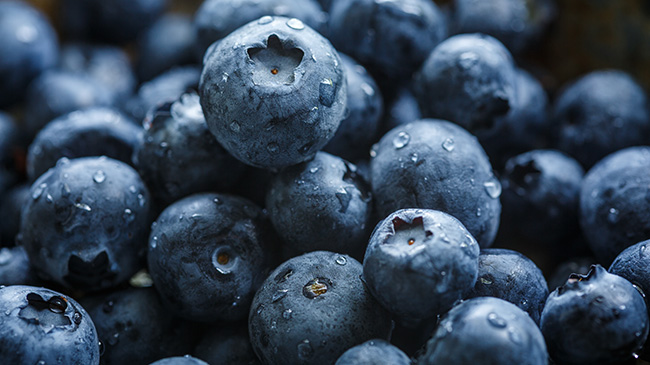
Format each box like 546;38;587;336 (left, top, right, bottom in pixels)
27;107;143;181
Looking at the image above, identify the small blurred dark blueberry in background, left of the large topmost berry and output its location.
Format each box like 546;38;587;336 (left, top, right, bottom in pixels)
136;14;196;80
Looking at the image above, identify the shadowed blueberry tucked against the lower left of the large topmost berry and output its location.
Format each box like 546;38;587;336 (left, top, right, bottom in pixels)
134;94;244;206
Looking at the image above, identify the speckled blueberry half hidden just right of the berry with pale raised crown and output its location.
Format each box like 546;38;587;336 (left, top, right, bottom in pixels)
466;248;548;324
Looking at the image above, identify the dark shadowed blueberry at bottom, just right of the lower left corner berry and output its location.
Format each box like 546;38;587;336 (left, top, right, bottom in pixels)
81;288;197;365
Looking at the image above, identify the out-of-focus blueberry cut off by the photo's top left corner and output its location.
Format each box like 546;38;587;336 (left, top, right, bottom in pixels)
0;1;59;108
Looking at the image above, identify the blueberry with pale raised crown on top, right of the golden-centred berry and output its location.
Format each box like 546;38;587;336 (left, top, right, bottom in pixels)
363;209;479;322
